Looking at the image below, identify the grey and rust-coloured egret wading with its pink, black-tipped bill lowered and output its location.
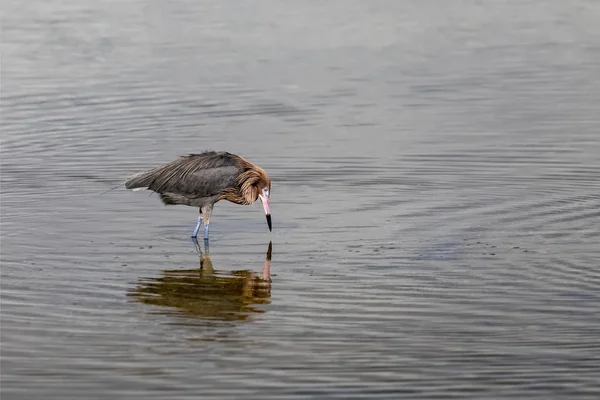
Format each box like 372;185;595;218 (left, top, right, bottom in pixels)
125;151;272;241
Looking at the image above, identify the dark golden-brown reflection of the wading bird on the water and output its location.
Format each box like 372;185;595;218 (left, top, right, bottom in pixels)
128;242;273;321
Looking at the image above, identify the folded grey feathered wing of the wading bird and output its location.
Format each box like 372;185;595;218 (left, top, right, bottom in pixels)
125;152;243;197
